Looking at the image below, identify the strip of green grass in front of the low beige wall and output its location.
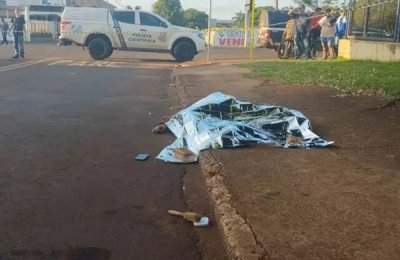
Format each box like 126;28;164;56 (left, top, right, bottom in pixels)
244;60;400;96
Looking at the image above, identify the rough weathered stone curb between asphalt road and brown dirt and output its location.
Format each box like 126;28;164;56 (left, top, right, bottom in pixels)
173;69;269;260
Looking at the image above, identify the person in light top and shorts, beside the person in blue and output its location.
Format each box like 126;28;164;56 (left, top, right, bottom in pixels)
318;8;336;59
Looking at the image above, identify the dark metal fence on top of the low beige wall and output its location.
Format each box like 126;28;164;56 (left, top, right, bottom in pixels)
348;0;400;42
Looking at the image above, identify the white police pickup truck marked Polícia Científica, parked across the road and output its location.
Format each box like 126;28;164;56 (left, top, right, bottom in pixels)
59;7;206;62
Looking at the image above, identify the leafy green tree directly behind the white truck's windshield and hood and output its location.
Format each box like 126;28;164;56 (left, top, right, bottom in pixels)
152;0;183;25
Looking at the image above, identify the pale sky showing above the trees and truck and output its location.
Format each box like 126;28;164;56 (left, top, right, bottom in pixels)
109;0;294;19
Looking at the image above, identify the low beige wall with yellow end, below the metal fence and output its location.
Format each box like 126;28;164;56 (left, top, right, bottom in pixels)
338;39;400;62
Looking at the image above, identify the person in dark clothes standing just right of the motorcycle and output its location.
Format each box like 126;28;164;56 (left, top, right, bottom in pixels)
294;5;312;59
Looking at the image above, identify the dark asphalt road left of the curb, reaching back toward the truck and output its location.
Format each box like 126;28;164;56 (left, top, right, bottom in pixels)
0;44;225;260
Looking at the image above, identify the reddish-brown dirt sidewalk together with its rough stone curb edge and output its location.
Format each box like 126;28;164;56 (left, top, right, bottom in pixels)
175;65;400;259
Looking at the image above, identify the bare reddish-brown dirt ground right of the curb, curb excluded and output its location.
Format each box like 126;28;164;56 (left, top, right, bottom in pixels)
216;78;400;259
